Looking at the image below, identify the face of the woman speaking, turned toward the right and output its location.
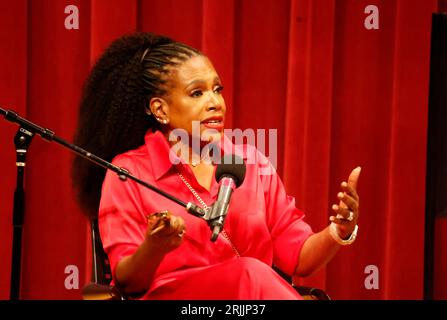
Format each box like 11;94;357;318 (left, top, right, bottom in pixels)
161;56;226;143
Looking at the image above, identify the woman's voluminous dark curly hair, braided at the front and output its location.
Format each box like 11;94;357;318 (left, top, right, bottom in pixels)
72;32;202;217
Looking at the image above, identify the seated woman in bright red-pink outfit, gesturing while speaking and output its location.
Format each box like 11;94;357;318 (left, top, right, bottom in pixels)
73;33;360;299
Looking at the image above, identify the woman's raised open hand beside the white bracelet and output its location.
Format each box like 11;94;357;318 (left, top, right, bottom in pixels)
329;167;361;239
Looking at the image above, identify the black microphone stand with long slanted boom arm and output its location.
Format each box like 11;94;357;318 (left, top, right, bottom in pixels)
0;108;208;300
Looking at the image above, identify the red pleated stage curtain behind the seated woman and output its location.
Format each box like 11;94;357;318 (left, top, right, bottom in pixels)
0;0;447;299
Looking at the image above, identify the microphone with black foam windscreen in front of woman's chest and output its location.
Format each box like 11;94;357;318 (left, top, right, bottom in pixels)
208;154;246;242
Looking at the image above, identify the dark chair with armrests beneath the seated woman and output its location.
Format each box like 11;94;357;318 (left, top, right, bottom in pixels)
82;219;331;300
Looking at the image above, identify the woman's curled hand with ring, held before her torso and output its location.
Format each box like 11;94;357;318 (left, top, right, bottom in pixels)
146;211;186;253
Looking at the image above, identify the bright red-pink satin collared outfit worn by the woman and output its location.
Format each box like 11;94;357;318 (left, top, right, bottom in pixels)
99;131;313;300
